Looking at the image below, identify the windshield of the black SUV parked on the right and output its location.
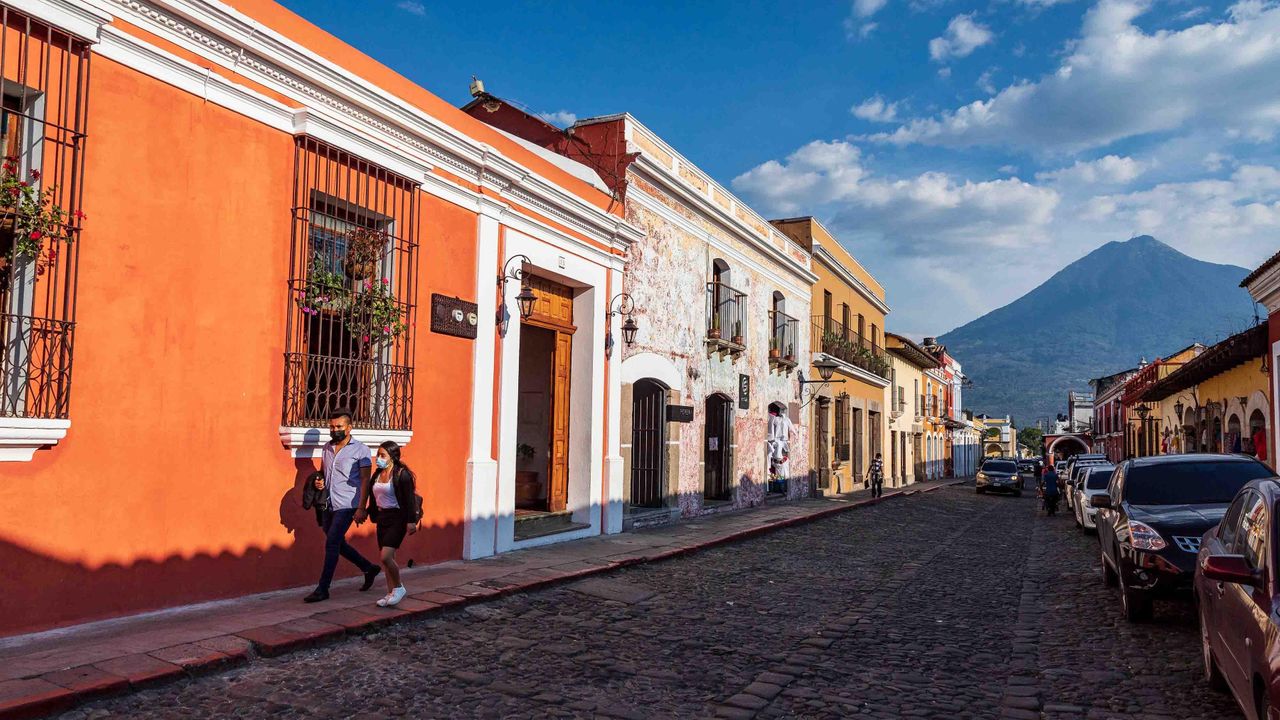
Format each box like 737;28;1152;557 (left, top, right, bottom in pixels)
1124;460;1271;505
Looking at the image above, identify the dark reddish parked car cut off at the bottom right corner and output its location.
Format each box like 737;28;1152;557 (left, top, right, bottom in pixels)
1196;478;1280;720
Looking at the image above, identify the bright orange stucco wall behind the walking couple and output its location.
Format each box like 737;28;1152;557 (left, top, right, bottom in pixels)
0;51;476;634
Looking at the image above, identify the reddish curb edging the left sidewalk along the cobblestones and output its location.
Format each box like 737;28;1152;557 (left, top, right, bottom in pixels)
0;479;968;720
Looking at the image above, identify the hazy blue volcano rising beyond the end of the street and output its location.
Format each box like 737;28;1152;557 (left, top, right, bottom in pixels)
938;236;1253;425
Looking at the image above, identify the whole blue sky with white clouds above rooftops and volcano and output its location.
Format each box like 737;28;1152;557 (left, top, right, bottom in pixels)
284;0;1280;337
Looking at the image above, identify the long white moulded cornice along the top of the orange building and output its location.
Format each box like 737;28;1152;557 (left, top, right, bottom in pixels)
100;0;643;251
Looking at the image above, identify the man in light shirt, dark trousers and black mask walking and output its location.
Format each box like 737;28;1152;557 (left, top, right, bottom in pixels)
302;410;380;602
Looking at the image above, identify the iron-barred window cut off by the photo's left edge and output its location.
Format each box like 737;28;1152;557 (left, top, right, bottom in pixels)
0;6;90;419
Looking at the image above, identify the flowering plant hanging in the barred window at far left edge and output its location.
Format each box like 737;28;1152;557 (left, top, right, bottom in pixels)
0;155;75;274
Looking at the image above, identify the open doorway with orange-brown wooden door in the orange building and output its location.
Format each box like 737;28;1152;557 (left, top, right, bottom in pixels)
516;275;576;515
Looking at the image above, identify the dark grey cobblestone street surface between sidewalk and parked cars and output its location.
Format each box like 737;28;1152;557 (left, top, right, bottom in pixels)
63;487;1240;719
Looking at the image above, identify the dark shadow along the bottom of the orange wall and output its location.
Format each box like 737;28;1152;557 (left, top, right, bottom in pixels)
0;459;462;635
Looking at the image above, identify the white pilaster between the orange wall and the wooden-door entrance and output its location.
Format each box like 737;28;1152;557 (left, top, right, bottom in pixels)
462;200;503;560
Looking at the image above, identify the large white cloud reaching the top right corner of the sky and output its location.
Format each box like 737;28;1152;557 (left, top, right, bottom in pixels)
872;0;1280;151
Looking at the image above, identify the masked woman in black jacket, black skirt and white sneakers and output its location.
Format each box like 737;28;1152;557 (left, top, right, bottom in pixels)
369;441;422;607
